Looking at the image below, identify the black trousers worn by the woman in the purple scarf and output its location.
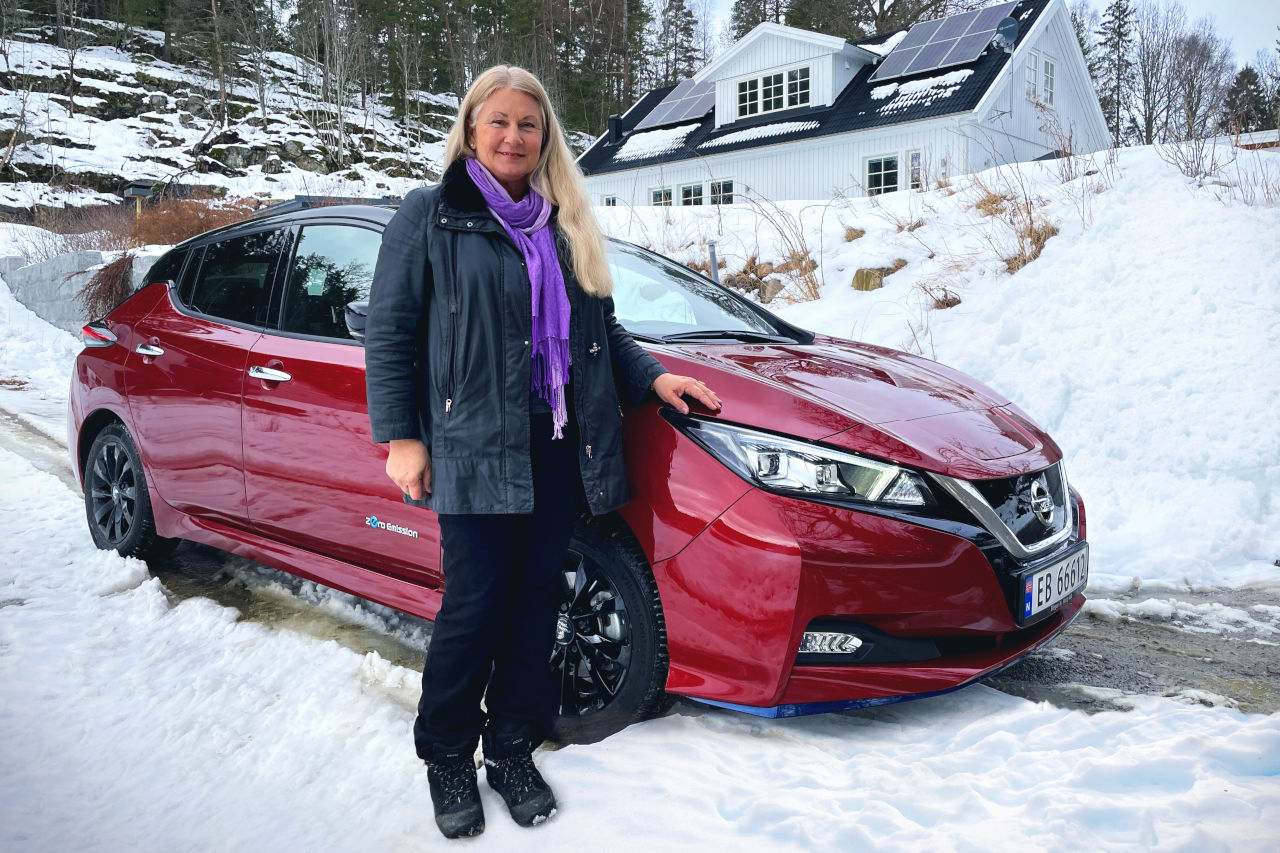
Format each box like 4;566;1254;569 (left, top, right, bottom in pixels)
413;410;585;761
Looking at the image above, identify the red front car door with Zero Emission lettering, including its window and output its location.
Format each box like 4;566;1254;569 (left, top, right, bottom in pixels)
244;220;440;585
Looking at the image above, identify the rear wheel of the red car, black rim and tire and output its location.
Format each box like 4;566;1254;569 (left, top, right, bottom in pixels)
84;424;178;560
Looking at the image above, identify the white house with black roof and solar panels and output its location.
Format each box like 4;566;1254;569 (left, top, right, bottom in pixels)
579;0;1110;205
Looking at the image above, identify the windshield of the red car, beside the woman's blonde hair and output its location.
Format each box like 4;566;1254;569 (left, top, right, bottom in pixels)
609;242;790;339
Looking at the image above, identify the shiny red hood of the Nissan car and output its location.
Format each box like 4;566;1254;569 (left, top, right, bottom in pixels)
650;336;1061;479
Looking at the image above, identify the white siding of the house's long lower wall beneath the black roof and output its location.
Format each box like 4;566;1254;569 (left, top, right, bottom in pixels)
586;118;968;205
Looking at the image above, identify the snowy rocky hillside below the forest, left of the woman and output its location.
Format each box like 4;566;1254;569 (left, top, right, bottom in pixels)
0;19;457;210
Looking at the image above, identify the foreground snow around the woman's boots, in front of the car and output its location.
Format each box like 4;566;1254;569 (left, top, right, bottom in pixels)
0;450;1280;852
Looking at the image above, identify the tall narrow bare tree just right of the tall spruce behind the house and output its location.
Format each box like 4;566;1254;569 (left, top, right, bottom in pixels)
1128;0;1187;145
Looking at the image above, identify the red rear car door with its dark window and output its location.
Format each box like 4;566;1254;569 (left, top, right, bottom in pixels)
128;227;289;526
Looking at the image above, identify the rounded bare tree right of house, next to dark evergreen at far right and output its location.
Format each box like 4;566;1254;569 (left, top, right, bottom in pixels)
1170;18;1235;140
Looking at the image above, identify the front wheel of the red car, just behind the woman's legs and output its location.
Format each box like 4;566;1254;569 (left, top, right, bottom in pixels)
550;517;667;743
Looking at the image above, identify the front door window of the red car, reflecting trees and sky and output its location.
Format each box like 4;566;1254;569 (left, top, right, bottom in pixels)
280;225;383;341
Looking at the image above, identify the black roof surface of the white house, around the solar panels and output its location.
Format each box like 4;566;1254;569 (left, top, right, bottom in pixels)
579;0;1050;174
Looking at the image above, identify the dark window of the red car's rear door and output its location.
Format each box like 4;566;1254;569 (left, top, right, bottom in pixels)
186;229;288;325
